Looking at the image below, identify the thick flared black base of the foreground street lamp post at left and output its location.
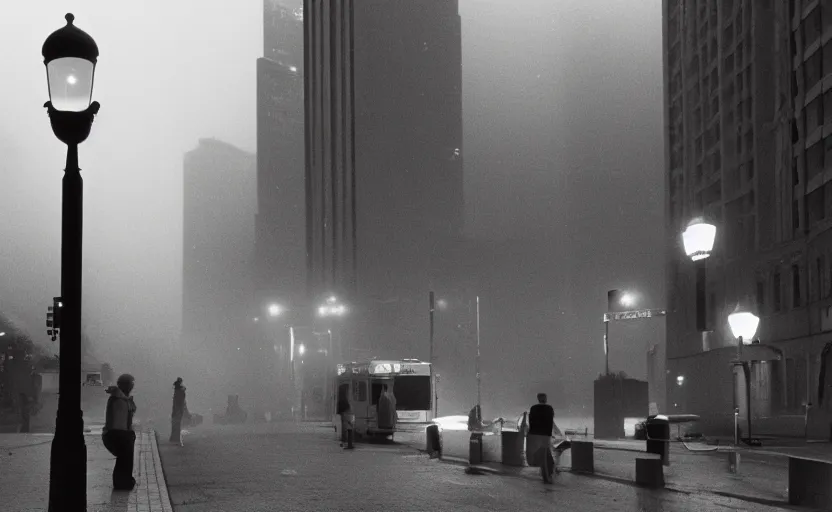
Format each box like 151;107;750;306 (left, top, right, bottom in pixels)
49;410;87;512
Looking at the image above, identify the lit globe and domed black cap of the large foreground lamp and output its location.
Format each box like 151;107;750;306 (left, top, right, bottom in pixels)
42;14;98;112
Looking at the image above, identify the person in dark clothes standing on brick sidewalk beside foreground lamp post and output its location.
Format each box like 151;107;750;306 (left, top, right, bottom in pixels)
101;373;136;491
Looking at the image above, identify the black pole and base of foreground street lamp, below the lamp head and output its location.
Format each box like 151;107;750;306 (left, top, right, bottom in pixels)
49;144;87;512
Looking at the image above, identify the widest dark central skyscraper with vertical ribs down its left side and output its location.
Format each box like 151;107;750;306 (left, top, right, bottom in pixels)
305;0;464;356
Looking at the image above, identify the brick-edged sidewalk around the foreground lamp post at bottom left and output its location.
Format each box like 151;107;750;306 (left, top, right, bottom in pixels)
0;431;173;512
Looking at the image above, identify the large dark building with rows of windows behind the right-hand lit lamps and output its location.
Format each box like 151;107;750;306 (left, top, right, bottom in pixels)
663;0;832;438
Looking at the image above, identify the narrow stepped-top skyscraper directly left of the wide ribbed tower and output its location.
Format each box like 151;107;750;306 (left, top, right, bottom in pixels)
256;0;307;306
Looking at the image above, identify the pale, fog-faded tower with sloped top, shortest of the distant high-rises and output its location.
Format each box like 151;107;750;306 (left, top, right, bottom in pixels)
181;139;257;390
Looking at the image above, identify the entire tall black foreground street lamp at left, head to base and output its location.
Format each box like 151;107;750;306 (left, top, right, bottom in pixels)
42;14;100;512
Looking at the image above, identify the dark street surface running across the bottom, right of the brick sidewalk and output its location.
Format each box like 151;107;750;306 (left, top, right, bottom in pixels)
159;424;792;512
